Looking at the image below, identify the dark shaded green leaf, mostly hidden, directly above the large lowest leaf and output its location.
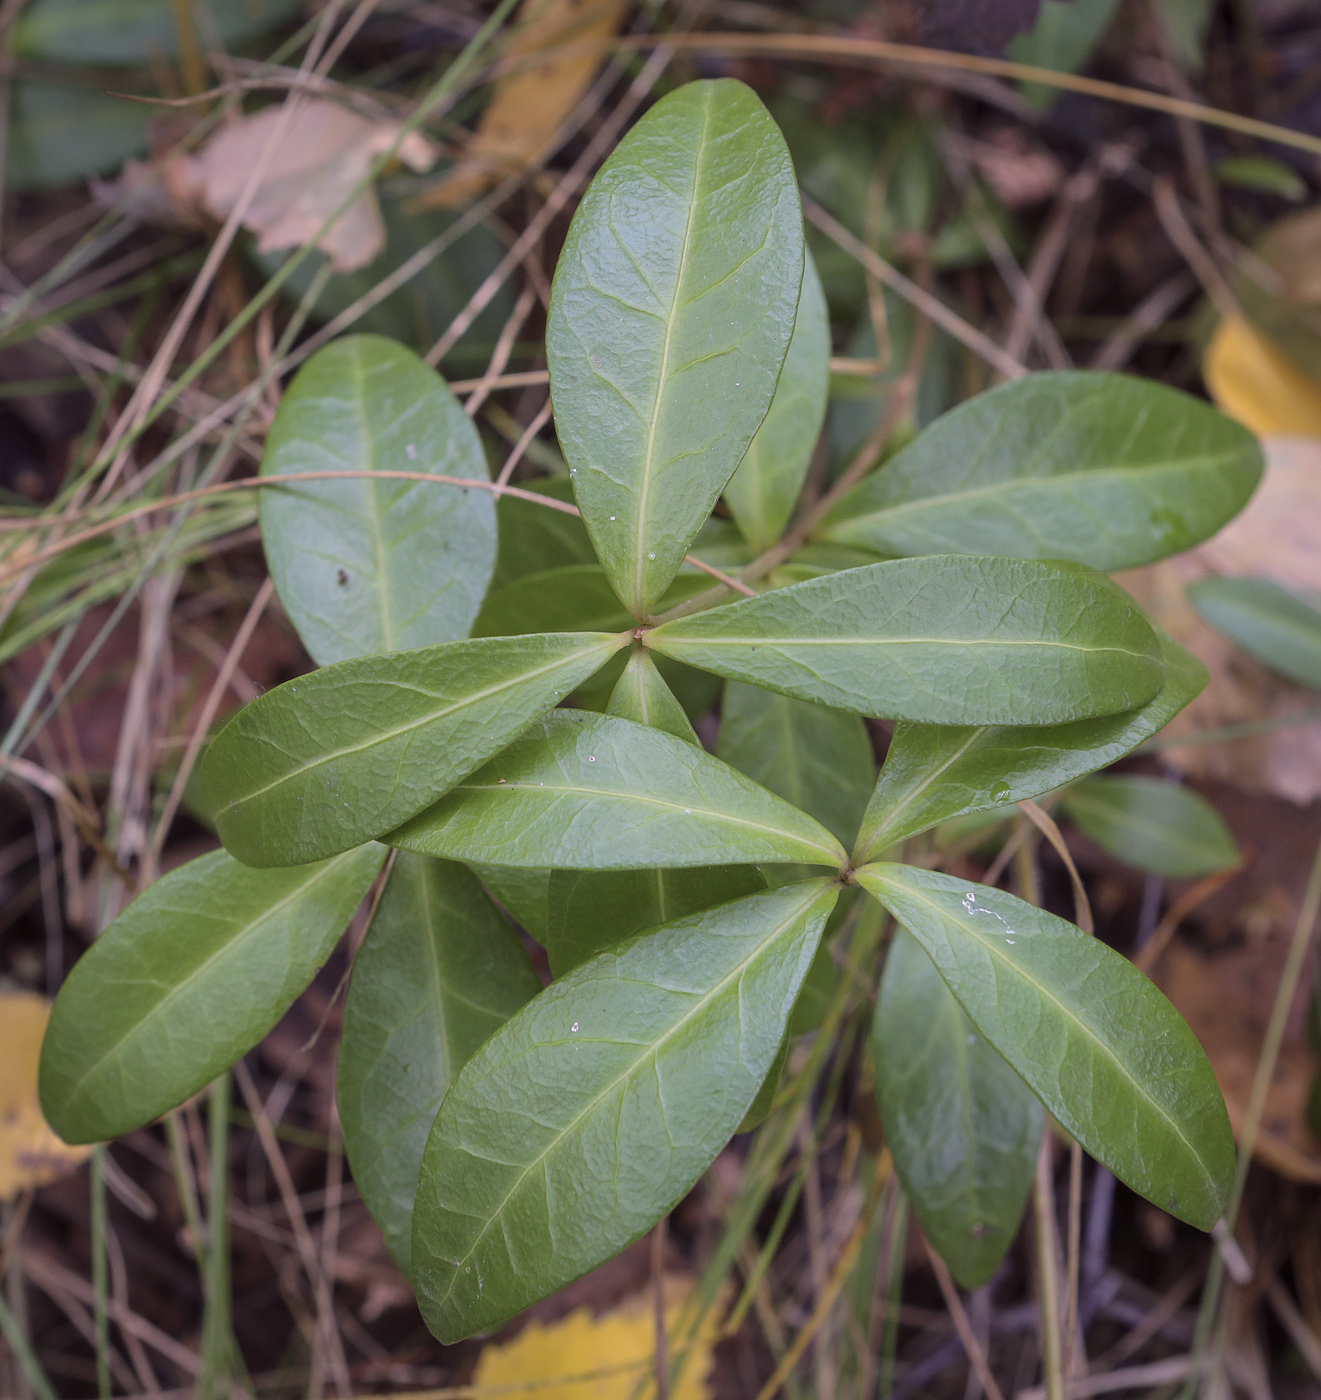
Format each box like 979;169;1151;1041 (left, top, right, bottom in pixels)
546;865;765;977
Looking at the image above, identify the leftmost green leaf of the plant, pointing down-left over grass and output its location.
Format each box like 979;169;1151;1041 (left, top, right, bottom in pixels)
41;846;386;1142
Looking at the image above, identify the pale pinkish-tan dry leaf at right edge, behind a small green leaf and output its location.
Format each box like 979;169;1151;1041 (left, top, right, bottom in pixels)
1118;437;1321;804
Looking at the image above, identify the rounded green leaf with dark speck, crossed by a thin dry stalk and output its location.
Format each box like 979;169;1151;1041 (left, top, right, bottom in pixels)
259;336;495;666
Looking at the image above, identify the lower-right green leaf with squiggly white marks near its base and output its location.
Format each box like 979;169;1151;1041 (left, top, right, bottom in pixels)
858;865;1234;1229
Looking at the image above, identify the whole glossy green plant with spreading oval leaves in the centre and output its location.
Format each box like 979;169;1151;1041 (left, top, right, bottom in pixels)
41;80;1261;1341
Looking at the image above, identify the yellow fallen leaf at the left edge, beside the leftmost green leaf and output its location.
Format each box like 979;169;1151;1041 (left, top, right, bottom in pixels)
0;991;91;1201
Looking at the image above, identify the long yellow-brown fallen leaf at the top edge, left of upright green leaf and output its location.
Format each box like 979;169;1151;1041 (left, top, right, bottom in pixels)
423;0;624;207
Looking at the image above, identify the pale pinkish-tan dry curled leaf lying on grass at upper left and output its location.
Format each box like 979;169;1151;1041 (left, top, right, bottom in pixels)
165;98;437;272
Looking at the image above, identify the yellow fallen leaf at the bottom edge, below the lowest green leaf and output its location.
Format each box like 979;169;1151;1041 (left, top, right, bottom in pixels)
473;1274;718;1400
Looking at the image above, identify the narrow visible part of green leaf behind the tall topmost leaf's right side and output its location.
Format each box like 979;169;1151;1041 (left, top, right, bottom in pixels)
725;256;830;550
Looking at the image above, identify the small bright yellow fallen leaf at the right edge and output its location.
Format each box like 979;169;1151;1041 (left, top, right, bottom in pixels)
1202;316;1321;438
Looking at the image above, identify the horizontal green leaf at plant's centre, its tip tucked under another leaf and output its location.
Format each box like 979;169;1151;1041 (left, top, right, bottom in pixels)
390;710;844;869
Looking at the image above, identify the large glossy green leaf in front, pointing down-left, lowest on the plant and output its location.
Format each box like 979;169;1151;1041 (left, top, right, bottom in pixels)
413;879;837;1343
